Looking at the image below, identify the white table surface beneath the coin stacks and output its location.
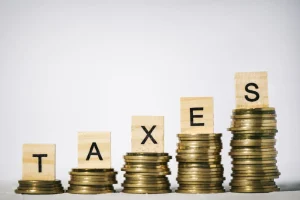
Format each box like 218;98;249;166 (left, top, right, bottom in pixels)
0;181;300;200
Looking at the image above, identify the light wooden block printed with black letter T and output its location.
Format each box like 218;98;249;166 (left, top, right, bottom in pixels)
22;144;56;180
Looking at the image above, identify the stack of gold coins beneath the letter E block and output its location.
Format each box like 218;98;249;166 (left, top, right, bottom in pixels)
176;133;225;194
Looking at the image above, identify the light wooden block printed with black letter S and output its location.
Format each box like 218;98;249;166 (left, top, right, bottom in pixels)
235;72;269;108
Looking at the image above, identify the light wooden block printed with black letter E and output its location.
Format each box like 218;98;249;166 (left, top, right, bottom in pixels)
180;97;214;133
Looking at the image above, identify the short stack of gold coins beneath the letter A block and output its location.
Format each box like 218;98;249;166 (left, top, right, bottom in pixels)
67;168;118;194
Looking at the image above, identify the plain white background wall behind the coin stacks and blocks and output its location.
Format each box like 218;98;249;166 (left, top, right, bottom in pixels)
0;0;300;191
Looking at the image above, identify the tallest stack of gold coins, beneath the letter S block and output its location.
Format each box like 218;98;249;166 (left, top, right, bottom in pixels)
228;108;280;193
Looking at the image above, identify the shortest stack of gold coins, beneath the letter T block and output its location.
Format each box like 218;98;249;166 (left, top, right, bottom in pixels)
15;180;64;194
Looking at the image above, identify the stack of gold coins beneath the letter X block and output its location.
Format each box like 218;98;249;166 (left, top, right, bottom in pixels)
122;153;172;194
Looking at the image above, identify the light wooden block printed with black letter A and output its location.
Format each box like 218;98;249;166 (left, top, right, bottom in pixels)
78;132;111;169
